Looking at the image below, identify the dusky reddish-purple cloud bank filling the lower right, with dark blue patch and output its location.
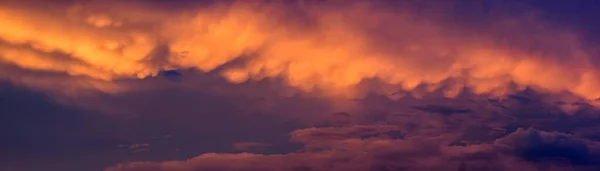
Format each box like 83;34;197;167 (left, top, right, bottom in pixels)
106;91;600;171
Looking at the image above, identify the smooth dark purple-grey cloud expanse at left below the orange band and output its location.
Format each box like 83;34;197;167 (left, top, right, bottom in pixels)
0;78;321;170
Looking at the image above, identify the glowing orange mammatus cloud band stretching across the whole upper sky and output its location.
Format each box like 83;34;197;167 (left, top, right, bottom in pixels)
0;1;600;99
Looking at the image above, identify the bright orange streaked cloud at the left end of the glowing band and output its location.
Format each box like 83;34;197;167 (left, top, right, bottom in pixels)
0;2;155;80
